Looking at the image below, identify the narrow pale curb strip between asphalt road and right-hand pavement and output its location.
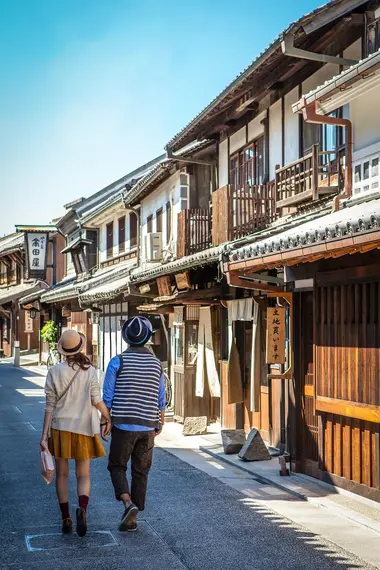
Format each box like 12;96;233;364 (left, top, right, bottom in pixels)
199;446;380;534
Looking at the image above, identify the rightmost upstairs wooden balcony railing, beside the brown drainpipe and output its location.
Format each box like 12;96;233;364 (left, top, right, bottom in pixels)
276;145;344;208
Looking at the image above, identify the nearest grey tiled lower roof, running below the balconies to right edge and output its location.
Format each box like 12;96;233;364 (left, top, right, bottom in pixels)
229;195;380;261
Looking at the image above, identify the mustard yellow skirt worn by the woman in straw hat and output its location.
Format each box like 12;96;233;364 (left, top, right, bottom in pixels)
49;429;106;460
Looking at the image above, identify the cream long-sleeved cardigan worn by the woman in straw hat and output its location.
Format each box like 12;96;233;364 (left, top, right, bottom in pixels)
45;362;102;436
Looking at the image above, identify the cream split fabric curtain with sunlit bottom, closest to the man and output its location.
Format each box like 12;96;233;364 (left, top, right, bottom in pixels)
195;307;220;398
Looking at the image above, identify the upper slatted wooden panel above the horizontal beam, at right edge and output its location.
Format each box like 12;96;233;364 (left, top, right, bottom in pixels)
315;282;380;411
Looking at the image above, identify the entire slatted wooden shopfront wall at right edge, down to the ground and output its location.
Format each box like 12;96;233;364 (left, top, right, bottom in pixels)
315;280;380;489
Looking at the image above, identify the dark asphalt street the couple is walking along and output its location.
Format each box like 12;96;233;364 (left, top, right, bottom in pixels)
0;365;373;570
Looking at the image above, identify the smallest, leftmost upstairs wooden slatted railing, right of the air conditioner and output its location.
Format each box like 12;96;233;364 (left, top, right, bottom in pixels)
177;208;211;257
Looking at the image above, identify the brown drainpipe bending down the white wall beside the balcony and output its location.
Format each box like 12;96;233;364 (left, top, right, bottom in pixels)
302;99;352;212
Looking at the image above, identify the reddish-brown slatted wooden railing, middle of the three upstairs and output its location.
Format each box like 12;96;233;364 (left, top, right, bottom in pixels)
212;182;276;245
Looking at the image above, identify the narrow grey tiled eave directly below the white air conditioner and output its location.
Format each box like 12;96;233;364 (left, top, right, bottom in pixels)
130;246;224;283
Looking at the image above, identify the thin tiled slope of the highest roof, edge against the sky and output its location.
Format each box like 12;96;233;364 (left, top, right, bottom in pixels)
166;0;364;149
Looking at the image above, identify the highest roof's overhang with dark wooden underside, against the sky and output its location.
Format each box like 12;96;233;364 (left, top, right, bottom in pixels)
166;0;367;150
